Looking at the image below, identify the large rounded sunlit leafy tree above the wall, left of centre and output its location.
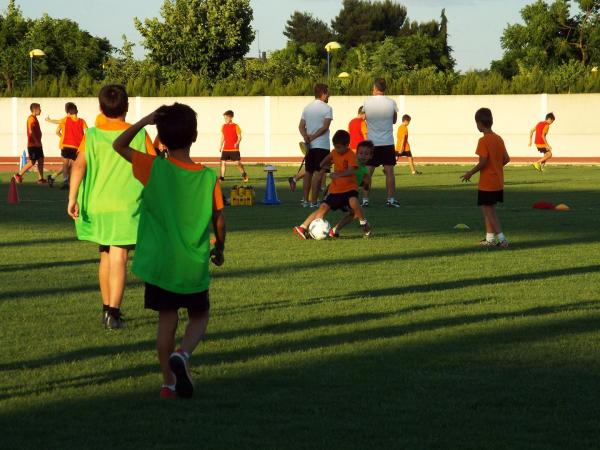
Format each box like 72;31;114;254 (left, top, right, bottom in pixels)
135;0;254;78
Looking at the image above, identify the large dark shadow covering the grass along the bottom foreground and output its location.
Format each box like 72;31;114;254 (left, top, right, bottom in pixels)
0;310;600;449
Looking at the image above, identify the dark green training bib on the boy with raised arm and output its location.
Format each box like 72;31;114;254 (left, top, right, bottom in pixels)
132;157;217;294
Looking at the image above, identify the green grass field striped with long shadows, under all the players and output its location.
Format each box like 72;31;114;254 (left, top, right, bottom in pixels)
0;166;600;449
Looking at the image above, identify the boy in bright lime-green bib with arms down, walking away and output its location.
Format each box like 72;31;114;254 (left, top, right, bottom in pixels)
67;85;155;329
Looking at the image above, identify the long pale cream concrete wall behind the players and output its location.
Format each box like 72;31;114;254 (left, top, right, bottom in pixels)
0;94;600;159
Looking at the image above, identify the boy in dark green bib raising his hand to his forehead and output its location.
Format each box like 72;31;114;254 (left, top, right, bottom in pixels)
113;103;225;398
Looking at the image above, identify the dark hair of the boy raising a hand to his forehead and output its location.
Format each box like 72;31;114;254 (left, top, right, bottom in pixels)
155;103;198;150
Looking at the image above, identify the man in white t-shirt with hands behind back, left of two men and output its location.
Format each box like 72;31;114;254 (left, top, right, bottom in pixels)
298;83;333;208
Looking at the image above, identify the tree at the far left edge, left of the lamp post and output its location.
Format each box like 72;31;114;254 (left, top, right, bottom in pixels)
0;0;30;92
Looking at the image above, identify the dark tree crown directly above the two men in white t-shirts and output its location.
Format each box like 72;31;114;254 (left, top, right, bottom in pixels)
331;0;407;47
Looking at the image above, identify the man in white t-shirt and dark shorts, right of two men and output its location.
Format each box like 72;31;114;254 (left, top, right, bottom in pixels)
362;78;400;208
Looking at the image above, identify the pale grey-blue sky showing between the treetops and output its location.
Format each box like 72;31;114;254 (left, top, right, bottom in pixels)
0;0;534;71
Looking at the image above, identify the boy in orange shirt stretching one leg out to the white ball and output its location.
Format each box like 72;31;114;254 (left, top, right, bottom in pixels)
294;130;371;239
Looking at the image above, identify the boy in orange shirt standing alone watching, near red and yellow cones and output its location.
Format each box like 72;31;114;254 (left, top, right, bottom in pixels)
461;108;510;248
